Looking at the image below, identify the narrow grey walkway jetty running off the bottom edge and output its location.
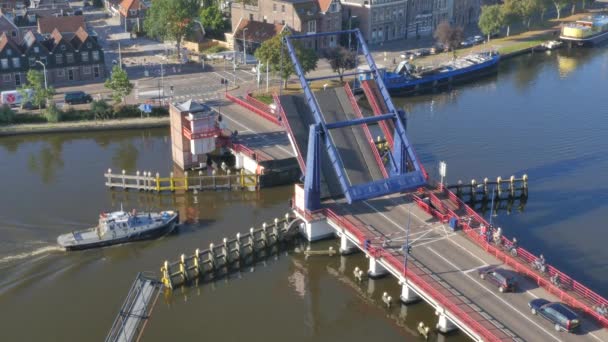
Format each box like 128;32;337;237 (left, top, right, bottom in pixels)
105;273;162;342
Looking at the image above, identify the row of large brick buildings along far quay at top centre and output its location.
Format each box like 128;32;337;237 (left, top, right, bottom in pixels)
229;0;485;50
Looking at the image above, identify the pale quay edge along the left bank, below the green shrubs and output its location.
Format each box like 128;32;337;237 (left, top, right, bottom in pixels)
0;116;169;137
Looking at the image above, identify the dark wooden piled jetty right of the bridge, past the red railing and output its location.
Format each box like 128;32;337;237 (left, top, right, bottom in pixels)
446;174;528;202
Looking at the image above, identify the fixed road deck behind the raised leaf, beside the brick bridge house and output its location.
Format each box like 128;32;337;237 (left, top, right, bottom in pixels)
217;99;295;159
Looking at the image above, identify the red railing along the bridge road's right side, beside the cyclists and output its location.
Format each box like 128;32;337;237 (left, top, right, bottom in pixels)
416;188;608;328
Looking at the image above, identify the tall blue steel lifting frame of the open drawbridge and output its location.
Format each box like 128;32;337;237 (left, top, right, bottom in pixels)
281;29;426;210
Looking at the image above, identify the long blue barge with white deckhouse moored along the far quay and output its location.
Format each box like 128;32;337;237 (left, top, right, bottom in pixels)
359;52;500;95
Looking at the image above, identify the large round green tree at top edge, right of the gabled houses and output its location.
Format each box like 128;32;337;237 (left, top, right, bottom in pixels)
144;0;201;60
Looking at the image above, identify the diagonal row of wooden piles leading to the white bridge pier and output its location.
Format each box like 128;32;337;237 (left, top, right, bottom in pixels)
160;214;299;289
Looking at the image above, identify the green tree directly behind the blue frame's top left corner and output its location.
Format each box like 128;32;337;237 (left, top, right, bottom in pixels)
255;31;319;88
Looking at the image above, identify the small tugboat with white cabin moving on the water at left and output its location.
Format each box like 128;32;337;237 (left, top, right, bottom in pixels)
57;208;179;251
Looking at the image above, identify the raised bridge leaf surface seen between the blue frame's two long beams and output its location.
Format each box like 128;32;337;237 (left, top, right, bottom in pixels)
315;87;384;185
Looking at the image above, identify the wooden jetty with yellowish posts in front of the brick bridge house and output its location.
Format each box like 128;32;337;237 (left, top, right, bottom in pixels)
103;169;259;192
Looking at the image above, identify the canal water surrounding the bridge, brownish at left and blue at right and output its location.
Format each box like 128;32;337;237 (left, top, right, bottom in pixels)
0;48;608;341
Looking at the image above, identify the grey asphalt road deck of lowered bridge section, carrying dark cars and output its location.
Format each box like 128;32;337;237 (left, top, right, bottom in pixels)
325;195;608;341
